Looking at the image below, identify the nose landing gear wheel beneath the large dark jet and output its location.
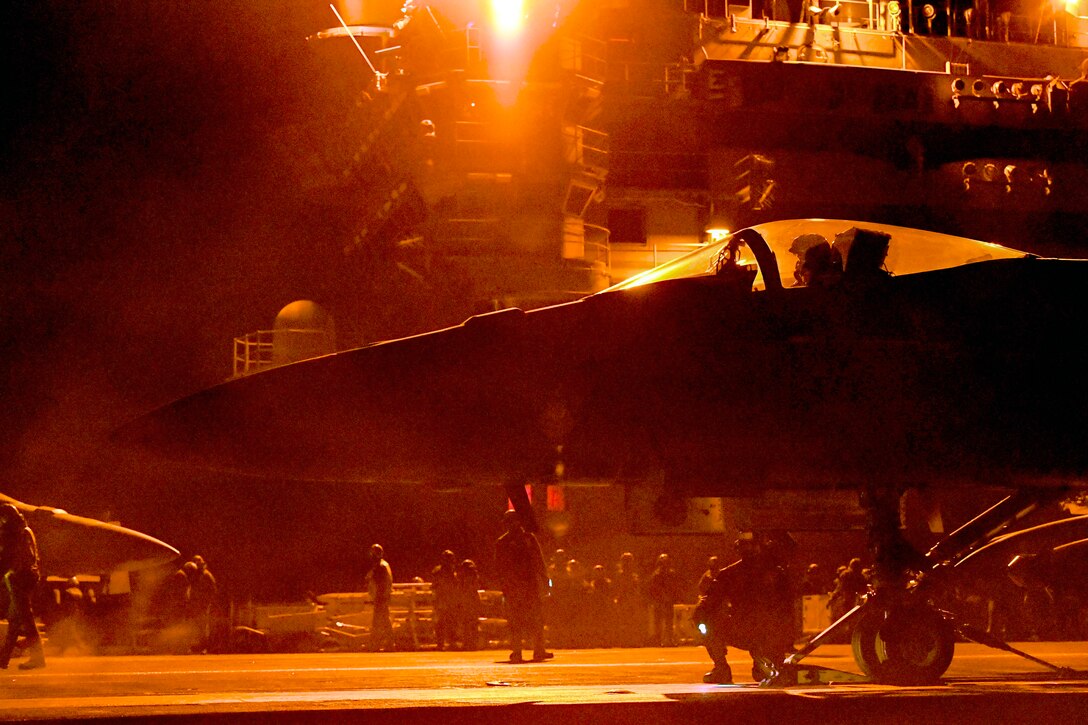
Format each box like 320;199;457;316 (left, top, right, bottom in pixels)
852;606;955;685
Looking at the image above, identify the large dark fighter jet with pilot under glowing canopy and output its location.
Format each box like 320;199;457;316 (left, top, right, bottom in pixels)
121;220;1088;683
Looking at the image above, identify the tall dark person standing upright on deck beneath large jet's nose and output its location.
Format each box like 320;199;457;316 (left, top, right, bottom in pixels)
495;511;552;662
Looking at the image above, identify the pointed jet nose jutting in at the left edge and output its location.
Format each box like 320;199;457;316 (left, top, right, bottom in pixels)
0;494;180;579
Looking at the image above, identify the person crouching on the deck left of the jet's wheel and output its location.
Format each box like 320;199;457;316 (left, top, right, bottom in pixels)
694;538;794;685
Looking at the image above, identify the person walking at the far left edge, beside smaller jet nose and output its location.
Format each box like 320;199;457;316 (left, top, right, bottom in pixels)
0;503;46;669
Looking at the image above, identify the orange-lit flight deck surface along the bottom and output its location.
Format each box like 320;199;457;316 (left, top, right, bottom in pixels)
0;642;1088;723
